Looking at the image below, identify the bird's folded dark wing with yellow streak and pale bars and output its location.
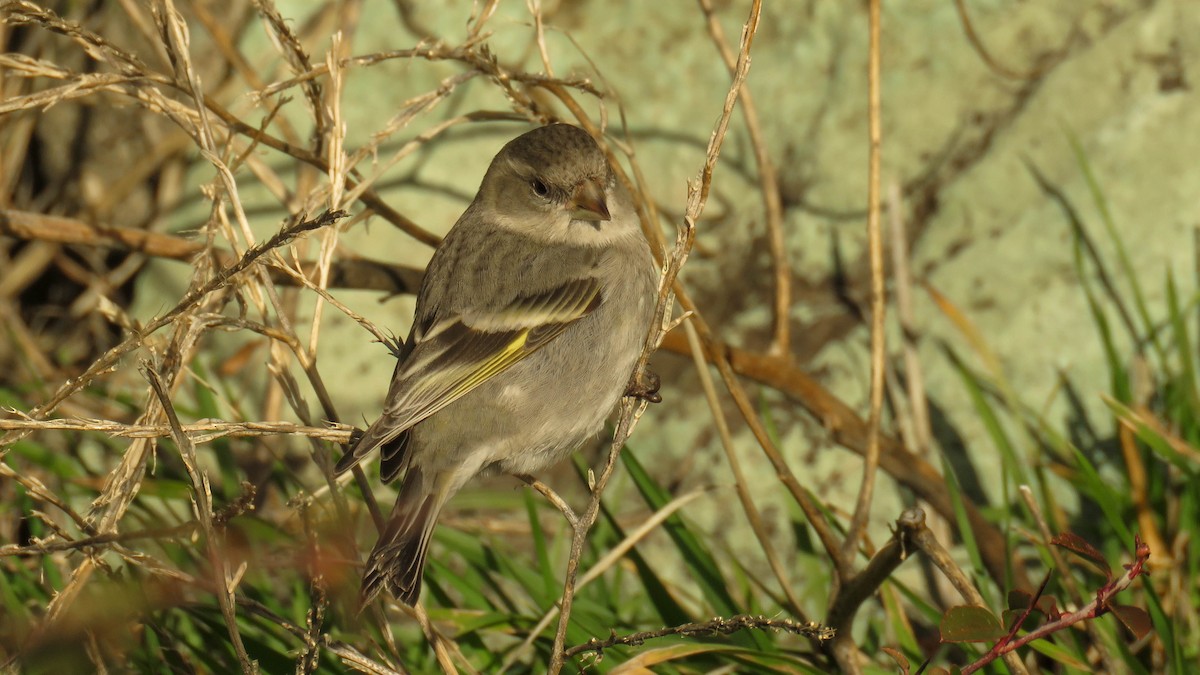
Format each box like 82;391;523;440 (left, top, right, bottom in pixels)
337;277;601;473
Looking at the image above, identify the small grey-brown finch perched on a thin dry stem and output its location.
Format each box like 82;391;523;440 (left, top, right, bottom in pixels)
335;124;659;607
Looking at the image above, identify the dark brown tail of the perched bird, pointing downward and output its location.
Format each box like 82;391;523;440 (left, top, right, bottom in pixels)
362;467;451;607
